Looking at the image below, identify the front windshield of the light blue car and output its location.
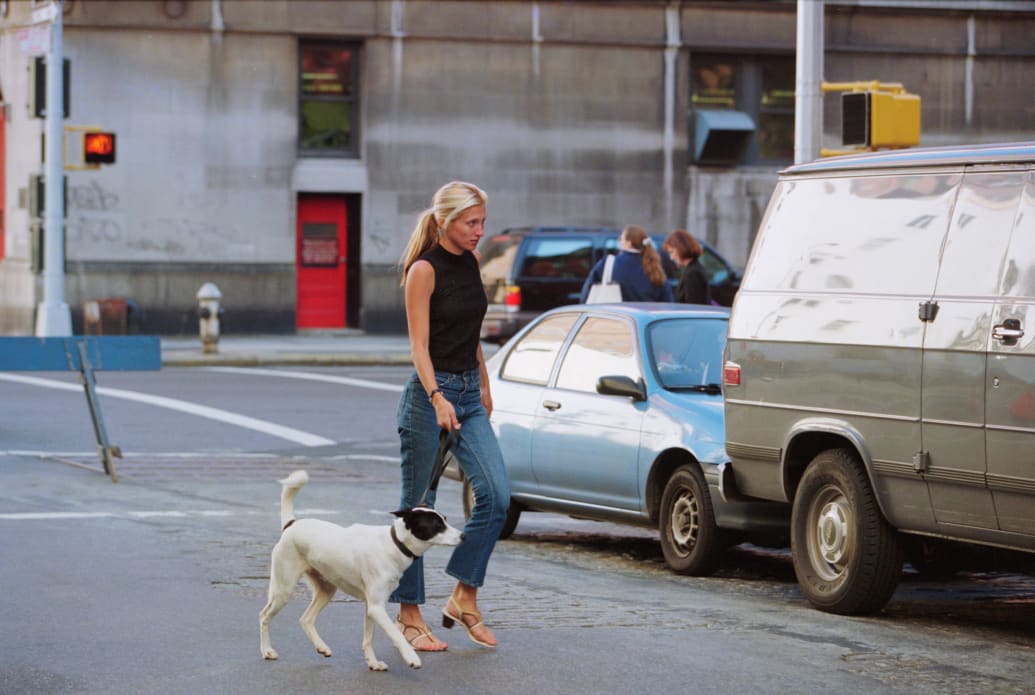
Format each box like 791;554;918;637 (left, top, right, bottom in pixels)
647;319;727;388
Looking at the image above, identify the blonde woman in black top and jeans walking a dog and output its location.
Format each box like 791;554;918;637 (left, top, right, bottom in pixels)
390;181;510;651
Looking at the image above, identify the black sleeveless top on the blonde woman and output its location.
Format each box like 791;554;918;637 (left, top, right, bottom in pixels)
418;244;489;373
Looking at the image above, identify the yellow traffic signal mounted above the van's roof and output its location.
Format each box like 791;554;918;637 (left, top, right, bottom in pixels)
841;89;920;149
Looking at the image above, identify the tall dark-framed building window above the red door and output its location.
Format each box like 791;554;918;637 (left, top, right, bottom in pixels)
298;41;359;156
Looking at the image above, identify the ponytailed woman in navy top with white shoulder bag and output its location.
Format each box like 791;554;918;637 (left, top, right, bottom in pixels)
582;225;672;302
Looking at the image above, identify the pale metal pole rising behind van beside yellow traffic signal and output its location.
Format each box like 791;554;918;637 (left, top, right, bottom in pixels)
794;0;824;164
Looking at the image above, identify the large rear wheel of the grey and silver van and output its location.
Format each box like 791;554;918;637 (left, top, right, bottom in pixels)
791;448;903;615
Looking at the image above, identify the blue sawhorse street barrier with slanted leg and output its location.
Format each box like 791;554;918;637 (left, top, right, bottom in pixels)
0;336;161;483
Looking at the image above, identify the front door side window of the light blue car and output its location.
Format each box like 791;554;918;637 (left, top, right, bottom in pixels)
557;317;640;394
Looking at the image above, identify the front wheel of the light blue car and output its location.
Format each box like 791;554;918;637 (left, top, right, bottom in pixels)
658;466;727;576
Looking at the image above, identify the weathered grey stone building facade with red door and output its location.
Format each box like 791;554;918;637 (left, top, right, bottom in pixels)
0;0;1035;335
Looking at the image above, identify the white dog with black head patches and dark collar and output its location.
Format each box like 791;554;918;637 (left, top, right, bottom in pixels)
259;470;464;671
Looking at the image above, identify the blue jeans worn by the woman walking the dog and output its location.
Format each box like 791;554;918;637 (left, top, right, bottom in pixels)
389;369;510;604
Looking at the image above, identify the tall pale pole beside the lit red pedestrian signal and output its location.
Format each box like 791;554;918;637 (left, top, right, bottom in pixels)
36;0;71;337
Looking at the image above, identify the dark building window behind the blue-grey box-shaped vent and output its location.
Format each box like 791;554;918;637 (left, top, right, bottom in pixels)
690;54;795;164
